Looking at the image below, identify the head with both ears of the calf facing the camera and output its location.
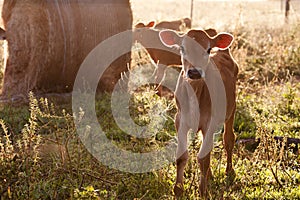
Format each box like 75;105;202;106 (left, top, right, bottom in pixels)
159;30;233;79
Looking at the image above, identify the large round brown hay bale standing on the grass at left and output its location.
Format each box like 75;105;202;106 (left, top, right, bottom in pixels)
2;0;132;99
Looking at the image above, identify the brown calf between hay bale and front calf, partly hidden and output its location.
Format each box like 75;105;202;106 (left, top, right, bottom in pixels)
133;21;217;95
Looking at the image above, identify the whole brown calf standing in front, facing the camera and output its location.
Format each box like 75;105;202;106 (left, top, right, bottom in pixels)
160;30;238;196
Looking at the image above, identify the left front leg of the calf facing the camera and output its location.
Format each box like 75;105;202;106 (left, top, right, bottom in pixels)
174;114;189;197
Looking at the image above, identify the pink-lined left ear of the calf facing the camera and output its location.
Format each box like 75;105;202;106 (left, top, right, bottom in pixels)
159;30;181;47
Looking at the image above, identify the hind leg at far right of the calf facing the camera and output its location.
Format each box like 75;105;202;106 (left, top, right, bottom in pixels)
223;111;235;175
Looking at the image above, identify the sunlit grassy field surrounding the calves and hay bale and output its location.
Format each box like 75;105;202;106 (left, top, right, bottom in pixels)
0;0;300;200
